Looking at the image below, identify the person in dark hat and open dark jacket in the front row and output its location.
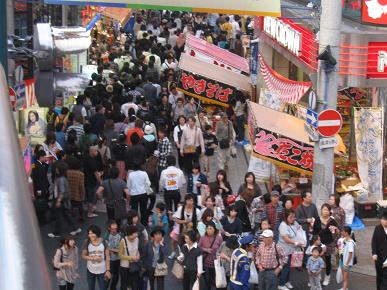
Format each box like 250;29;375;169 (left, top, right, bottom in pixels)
143;226;166;290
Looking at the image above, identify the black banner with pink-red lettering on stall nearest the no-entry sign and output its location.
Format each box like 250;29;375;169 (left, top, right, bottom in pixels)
252;128;314;174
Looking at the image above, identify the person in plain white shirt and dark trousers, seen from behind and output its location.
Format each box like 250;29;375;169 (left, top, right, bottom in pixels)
127;164;151;226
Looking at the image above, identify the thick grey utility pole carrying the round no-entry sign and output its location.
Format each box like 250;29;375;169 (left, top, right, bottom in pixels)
312;0;342;208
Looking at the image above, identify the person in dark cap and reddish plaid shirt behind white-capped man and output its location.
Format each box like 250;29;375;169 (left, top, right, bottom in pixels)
261;190;284;241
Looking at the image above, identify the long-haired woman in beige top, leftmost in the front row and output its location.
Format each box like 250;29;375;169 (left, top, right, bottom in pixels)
53;235;79;290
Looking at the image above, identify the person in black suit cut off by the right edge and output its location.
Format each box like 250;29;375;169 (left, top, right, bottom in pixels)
371;212;387;290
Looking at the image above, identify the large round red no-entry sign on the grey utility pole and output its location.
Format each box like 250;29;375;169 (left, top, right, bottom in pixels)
317;109;343;137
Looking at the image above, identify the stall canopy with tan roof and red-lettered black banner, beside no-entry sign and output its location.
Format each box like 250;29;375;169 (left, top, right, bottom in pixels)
248;102;314;174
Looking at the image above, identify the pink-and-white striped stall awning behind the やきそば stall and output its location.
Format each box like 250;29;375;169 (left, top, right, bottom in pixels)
185;34;250;74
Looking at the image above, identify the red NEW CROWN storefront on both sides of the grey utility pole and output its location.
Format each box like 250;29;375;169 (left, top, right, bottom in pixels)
256;17;387;218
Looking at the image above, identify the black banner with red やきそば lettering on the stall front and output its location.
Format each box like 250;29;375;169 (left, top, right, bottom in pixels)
179;71;237;107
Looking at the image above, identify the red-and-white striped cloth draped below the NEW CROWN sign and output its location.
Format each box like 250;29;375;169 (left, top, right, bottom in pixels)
259;54;312;104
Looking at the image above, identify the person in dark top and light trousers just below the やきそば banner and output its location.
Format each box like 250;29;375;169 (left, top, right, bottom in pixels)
215;113;235;170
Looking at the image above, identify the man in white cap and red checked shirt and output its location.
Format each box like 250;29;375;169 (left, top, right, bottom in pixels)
255;230;288;290
